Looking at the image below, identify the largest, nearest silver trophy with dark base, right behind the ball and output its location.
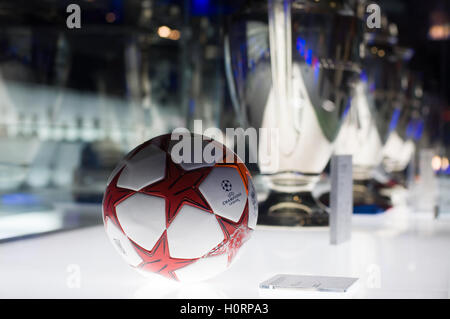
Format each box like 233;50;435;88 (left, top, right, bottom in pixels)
225;0;362;225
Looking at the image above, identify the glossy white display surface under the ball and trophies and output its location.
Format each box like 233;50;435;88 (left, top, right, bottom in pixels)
0;208;450;298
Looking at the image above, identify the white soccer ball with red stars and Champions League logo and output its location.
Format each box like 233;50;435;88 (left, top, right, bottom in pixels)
103;134;258;281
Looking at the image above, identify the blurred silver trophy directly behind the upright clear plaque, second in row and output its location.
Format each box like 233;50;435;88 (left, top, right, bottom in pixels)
330;18;403;213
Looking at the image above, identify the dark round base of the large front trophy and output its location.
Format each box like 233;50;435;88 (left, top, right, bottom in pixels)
258;191;329;227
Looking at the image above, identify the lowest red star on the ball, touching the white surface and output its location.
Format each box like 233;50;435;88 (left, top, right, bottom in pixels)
131;230;197;280
